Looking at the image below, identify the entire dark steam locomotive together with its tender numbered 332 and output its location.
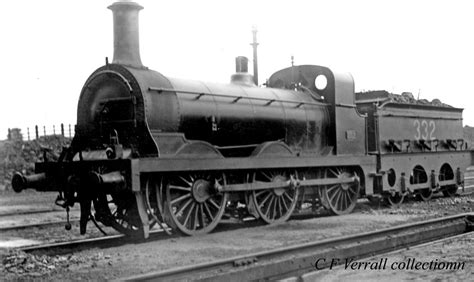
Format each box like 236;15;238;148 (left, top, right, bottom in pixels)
12;2;472;238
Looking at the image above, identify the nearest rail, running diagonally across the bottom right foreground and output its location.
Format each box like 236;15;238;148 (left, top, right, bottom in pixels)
123;213;474;282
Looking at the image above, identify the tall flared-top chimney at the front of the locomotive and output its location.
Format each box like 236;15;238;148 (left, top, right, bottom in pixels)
108;1;143;68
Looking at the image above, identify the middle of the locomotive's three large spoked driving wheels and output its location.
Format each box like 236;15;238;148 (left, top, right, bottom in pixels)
251;171;298;224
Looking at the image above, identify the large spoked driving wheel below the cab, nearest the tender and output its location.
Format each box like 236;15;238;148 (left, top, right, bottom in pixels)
321;168;360;215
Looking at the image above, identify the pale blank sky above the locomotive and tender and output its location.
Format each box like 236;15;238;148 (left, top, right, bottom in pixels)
0;0;474;140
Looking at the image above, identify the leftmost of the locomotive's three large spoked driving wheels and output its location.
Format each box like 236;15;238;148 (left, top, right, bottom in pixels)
164;173;227;235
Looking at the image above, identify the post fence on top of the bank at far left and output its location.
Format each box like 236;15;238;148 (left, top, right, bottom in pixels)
7;123;75;141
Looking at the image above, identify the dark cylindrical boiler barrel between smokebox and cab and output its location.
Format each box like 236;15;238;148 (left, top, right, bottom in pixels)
146;75;329;151
